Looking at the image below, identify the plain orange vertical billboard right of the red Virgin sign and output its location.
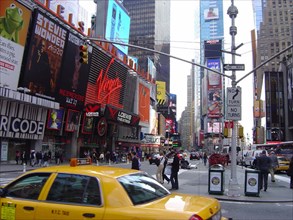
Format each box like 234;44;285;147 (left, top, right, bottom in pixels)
138;83;150;124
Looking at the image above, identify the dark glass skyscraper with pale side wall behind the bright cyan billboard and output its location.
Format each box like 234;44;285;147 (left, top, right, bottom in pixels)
123;0;170;93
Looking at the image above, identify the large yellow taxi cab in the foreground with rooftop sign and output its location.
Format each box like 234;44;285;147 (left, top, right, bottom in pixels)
0;158;226;220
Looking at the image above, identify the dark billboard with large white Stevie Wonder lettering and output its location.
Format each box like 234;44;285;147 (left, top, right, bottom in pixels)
22;11;67;100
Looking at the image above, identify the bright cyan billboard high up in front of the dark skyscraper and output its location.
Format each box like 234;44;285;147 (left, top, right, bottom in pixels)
105;0;130;55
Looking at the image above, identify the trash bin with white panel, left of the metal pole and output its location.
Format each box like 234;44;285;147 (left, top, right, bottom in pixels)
209;164;225;195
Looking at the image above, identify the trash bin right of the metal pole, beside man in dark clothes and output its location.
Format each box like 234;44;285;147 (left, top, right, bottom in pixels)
244;170;260;196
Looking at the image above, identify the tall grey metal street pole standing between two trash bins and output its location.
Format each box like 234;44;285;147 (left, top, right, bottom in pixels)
227;0;240;196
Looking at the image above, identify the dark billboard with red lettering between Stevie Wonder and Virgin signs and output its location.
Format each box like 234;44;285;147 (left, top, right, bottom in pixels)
56;33;91;110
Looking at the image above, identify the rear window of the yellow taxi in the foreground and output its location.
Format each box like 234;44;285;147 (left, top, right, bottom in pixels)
118;173;170;205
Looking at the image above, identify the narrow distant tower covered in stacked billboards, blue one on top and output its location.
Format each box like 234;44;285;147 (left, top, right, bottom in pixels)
197;0;225;152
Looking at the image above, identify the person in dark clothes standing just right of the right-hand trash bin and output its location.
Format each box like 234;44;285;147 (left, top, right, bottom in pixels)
256;150;272;191
